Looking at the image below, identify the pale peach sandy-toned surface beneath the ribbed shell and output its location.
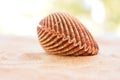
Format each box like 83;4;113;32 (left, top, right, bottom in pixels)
0;36;120;80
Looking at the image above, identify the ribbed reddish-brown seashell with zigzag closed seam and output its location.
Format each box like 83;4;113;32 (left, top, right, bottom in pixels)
37;12;99;56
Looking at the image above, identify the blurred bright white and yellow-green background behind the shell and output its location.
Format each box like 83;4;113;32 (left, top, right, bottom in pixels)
0;0;120;37
